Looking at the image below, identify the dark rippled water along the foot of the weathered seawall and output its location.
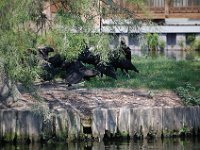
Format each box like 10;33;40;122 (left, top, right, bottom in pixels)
0;138;200;150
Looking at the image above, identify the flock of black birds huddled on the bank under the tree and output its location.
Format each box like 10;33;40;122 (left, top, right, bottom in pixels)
38;41;139;86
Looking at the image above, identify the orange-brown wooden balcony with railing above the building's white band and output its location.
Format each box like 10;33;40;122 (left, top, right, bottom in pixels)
102;0;200;19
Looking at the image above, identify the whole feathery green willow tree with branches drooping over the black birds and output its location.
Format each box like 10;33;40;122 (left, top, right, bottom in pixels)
0;0;147;103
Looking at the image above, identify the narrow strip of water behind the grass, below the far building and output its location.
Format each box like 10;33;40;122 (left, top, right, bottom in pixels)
132;50;200;61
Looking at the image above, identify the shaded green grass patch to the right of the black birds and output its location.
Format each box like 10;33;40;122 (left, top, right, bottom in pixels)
85;57;200;105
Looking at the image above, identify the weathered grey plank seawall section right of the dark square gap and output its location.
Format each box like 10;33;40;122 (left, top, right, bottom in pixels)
92;106;200;138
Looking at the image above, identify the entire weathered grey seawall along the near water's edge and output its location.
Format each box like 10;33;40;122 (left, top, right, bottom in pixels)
0;107;200;142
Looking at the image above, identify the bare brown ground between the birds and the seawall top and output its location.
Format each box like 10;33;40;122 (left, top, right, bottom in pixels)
0;83;183;116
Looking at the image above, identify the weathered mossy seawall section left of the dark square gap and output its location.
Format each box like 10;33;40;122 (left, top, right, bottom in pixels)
0;106;80;143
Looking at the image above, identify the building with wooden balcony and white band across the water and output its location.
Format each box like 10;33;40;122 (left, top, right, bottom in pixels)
45;0;200;50
